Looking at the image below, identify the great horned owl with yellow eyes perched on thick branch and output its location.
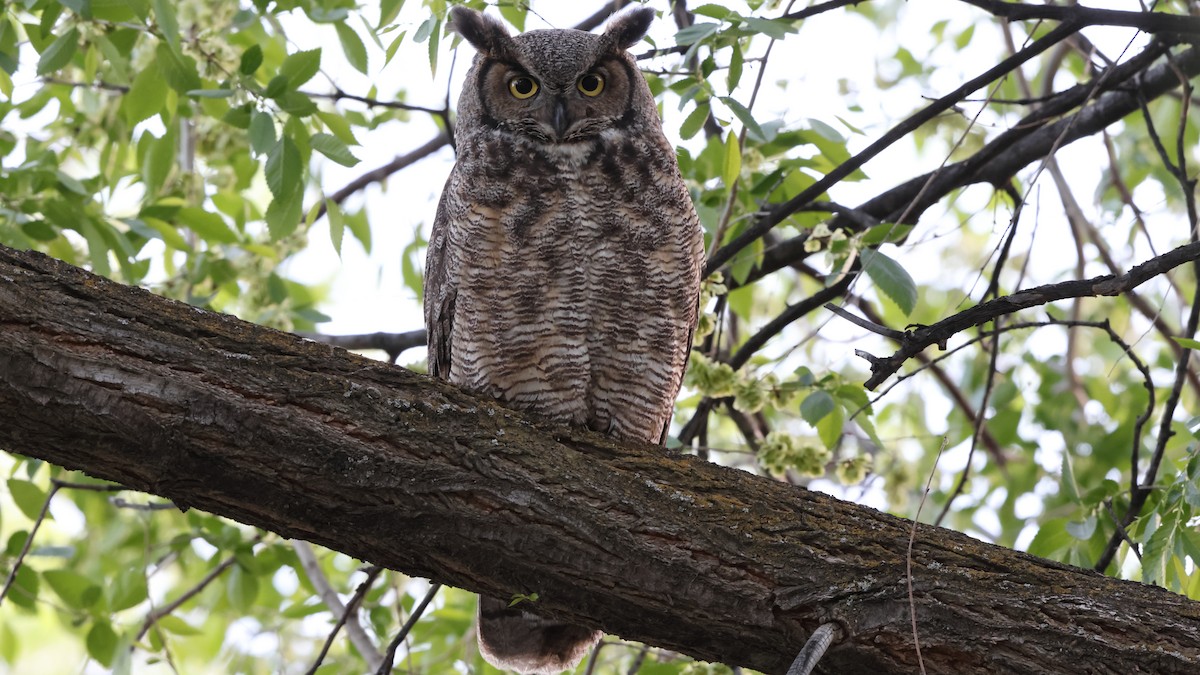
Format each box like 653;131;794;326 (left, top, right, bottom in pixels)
425;7;704;673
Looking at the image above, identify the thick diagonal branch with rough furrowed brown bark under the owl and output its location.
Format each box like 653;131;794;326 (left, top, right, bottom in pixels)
0;242;1200;674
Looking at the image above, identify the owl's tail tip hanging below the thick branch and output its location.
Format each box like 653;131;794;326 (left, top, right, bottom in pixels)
479;596;604;675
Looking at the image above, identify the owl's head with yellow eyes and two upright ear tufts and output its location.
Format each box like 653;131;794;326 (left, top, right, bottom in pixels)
450;7;658;144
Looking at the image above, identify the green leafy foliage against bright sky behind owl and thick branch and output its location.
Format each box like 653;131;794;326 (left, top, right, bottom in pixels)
0;0;1200;674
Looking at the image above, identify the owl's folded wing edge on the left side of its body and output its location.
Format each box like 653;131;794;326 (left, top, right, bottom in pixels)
425;190;458;380
